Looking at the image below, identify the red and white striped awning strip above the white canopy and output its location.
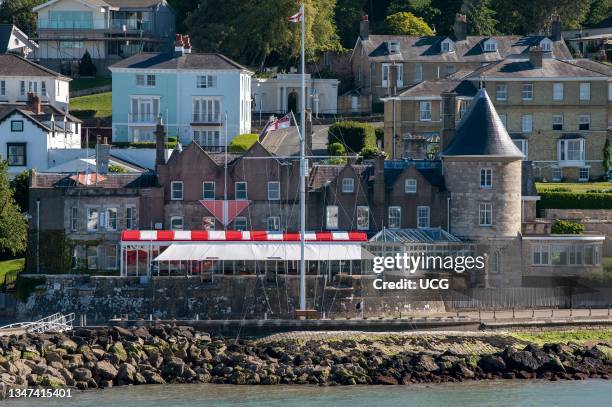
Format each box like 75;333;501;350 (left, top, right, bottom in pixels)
121;230;368;243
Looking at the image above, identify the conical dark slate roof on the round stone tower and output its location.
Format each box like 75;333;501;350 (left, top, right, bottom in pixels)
441;88;524;158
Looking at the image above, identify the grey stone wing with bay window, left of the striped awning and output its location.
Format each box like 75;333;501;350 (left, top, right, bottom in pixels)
28;171;163;273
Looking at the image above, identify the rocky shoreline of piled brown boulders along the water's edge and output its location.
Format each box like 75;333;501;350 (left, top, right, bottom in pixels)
0;325;612;399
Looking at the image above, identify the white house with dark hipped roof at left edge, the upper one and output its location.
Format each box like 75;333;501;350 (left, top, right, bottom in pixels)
0;53;71;110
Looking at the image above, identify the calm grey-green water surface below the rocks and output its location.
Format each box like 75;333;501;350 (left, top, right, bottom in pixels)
0;380;612;407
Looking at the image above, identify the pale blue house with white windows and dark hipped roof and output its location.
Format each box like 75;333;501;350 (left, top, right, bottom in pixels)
110;47;253;151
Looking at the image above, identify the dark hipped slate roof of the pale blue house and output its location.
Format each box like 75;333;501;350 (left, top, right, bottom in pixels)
110;52;248;71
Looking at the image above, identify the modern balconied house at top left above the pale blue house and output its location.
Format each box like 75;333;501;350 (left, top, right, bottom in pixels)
33;0;175;75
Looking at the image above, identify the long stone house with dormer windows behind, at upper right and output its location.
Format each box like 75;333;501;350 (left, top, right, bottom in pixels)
351;14;571;111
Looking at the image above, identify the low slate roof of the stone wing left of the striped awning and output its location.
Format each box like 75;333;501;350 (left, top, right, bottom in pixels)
32;172;157;189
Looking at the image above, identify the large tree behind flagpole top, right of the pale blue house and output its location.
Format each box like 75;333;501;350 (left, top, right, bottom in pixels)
187;0;341;68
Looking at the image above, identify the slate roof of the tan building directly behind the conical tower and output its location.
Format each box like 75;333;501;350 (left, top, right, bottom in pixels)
469;58;612;80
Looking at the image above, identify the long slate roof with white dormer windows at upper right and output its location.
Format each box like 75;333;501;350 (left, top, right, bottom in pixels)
361;35;572;62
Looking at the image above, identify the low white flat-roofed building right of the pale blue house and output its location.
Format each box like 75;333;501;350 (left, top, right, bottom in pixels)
252;73;339;116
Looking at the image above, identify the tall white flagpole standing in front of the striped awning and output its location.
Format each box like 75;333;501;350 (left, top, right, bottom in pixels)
300;3;308;310
